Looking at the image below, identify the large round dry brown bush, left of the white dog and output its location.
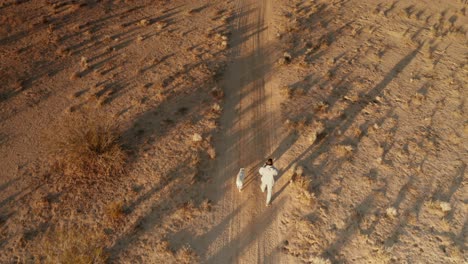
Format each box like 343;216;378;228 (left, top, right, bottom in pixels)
55;117;127;177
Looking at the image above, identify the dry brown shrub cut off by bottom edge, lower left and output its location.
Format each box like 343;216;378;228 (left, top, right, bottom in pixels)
40;227;107;264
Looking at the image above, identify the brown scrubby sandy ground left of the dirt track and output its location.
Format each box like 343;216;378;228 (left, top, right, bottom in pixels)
0;1;232;263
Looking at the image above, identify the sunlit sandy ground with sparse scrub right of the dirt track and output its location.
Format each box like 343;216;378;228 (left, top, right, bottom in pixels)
273;1;468;263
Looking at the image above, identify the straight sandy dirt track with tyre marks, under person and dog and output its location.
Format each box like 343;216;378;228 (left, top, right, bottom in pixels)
194;0;292;263
